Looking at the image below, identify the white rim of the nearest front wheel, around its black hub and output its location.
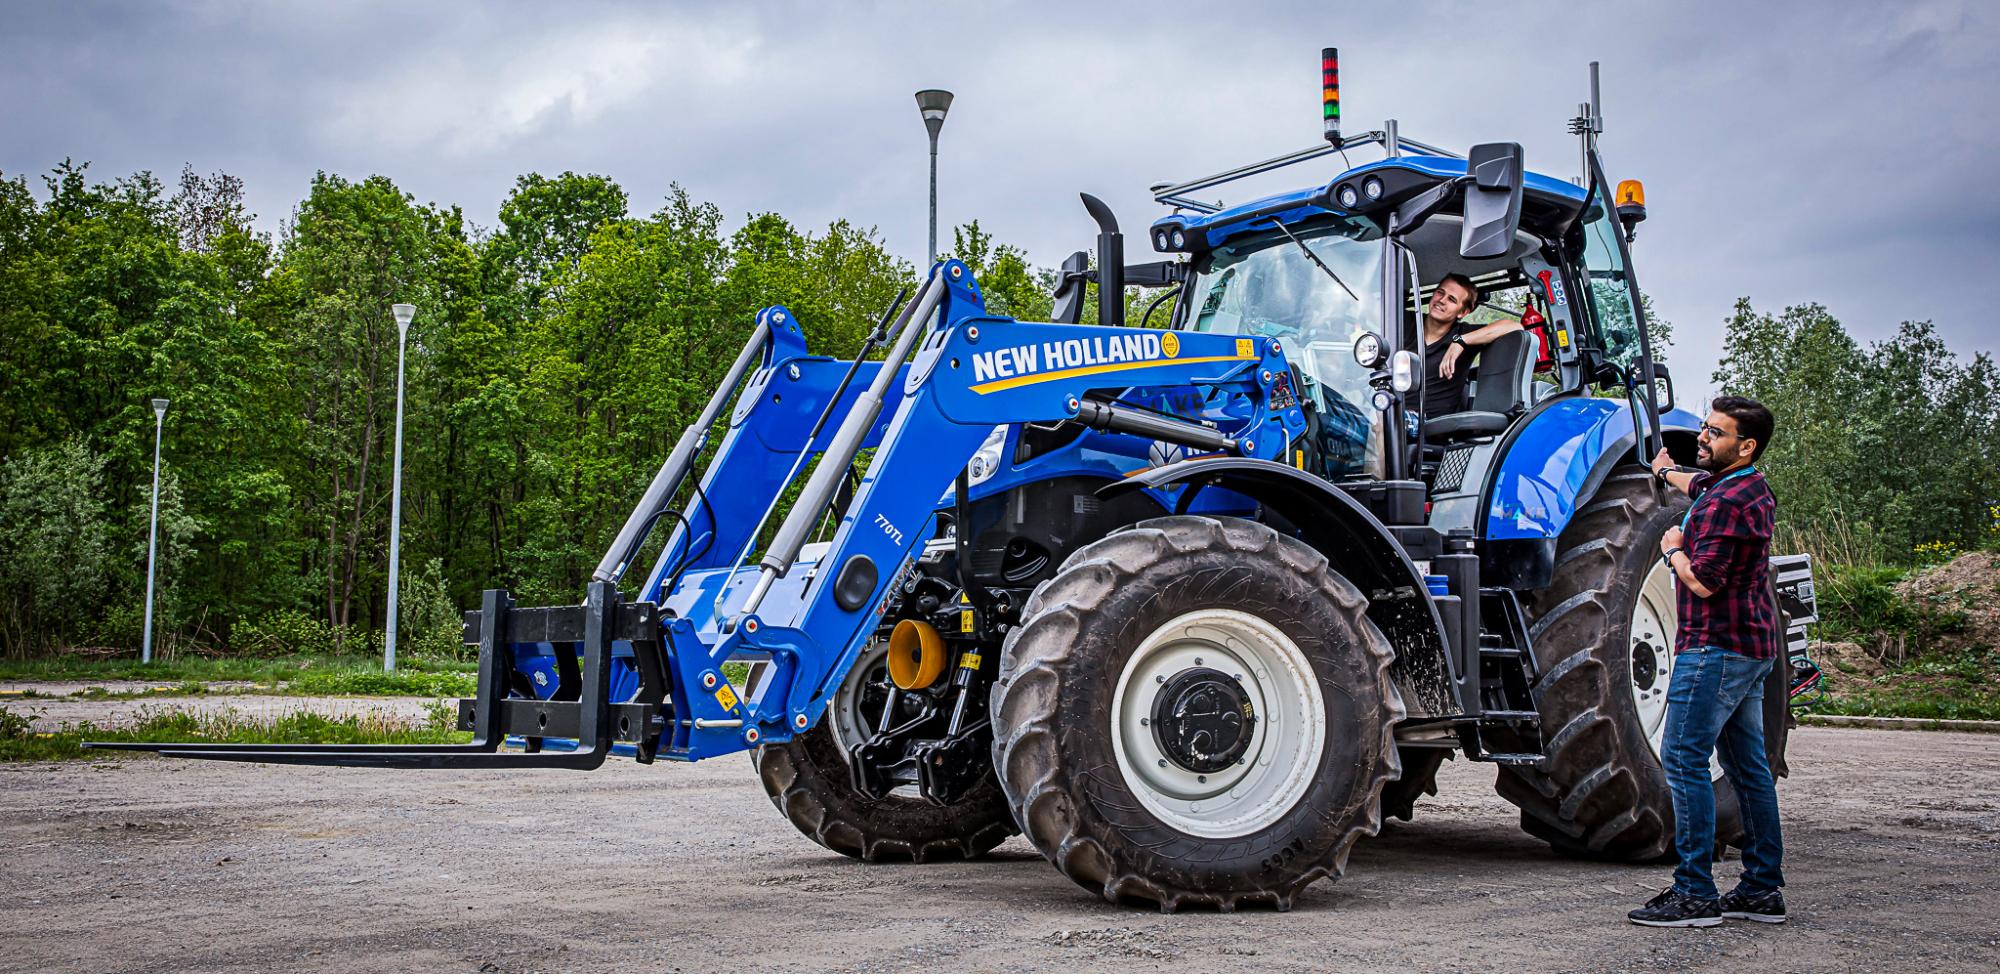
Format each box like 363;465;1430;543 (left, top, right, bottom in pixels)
1112;608;1326;838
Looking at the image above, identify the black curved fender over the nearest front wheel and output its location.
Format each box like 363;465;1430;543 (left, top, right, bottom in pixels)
1098;458;1458;716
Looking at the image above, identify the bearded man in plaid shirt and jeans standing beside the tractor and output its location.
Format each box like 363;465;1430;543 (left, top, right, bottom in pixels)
1628;396;1786;926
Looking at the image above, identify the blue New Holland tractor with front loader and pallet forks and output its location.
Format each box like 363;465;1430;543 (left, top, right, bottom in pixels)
101;52;1810;910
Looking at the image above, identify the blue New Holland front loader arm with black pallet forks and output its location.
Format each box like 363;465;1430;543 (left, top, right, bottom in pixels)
97;260;1306;768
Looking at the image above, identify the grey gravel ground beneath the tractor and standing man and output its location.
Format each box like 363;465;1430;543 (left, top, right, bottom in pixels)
0;728;2000;974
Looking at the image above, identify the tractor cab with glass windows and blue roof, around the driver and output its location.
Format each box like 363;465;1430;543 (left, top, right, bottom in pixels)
1150;147;1664;510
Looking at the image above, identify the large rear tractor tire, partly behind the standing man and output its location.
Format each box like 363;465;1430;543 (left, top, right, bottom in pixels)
1494;466;1788;862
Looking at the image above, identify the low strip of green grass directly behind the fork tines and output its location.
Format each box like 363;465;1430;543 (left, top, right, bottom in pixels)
0;702;472;760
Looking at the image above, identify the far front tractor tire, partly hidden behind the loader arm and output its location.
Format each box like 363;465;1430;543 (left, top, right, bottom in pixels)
750;644;1020;862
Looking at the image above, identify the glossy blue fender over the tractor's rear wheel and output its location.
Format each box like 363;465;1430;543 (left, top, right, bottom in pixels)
1480;396;1702;588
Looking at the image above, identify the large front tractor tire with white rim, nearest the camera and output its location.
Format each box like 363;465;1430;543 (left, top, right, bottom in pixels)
992;516;1404;912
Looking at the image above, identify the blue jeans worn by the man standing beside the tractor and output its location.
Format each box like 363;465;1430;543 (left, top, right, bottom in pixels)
1660;646;1784;900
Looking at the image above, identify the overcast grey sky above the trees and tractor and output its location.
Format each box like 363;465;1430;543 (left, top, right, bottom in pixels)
0;0;2000;402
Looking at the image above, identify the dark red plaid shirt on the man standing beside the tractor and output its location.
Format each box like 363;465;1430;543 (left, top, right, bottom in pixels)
1674;472;1778;660
